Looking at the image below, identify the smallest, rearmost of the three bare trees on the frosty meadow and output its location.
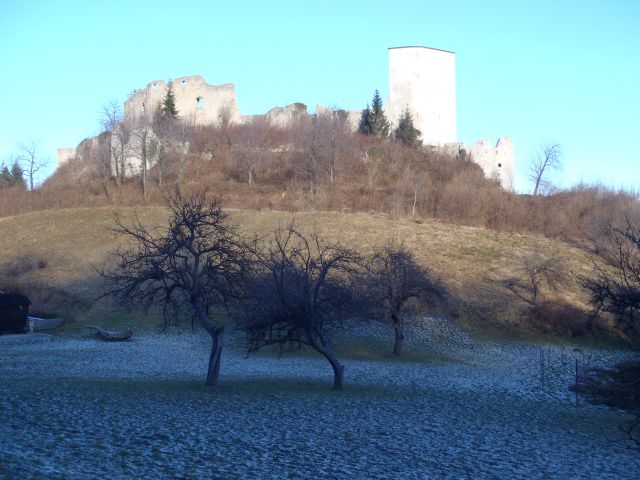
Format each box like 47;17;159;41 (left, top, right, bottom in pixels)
362;243;445;355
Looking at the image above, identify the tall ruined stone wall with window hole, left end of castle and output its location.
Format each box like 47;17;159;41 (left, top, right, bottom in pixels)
124;75;241;125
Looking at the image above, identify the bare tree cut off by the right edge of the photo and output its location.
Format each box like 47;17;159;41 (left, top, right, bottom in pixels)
580;220;640;336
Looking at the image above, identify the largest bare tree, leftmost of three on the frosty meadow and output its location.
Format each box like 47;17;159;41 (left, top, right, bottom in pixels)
99;190;250;386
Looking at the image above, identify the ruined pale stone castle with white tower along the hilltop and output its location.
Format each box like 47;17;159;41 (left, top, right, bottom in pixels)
58;47;514;190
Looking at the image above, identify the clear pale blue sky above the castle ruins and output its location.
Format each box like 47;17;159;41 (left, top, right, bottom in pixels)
0;0;640;191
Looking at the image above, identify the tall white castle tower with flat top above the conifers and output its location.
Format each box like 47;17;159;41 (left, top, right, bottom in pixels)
387;47;456;146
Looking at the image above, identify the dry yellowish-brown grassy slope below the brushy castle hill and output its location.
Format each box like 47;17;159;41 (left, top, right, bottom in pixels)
0;207;591;333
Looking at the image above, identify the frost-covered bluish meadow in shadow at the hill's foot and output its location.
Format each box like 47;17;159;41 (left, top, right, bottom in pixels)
0;319;640;479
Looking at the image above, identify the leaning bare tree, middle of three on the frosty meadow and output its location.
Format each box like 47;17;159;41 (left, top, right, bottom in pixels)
242;224;361;389
